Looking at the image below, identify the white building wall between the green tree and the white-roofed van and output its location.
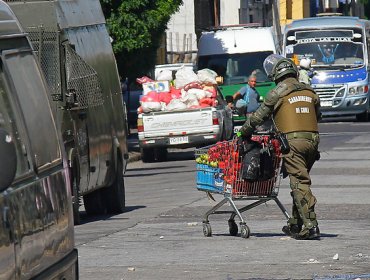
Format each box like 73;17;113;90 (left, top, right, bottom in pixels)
166;0;197;63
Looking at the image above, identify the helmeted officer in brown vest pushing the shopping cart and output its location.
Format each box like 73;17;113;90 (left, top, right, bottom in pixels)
239;54;320;239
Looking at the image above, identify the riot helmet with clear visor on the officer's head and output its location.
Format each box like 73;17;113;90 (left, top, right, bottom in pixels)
263;54;298;81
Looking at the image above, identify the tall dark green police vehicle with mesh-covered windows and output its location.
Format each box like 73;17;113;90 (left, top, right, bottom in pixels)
5;0;128;224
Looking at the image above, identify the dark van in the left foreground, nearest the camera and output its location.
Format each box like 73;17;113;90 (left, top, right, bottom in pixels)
0;1;78;280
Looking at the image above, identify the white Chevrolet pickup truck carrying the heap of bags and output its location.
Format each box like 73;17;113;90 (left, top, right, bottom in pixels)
137;93;233;162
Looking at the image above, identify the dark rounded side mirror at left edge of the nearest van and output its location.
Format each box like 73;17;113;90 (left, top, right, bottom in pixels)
0;128;17;191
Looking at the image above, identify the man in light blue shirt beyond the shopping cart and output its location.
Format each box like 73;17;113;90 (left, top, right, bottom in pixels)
233;75;260;115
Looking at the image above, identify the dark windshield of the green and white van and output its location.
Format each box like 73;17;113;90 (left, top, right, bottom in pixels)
198;51;272;85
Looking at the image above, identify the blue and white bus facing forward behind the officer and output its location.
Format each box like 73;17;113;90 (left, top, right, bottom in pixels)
283;15;370;121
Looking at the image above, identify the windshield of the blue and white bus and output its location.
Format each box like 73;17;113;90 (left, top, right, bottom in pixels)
285;30;364;69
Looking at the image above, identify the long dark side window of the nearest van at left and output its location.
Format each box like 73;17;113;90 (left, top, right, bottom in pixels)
3;51;61;168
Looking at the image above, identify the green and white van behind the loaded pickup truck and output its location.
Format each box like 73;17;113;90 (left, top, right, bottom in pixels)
197;24;280;131
